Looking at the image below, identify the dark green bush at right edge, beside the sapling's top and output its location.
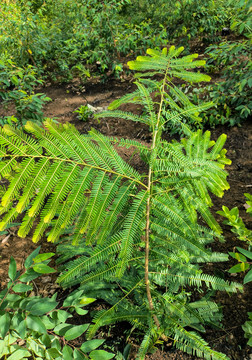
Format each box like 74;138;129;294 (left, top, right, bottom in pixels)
189;41;252;126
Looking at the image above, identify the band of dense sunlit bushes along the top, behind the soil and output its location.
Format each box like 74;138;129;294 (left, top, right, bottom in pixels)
0;0;242;80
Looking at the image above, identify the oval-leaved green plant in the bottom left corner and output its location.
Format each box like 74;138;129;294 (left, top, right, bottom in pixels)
0;247;114;360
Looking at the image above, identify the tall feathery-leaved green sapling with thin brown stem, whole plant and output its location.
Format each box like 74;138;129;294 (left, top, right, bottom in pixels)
0;46;242;360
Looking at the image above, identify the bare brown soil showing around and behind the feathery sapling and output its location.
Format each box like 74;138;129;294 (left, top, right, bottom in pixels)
0;76;252;360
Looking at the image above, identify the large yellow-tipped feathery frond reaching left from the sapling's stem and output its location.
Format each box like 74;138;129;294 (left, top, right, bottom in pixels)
0;120;146;242
